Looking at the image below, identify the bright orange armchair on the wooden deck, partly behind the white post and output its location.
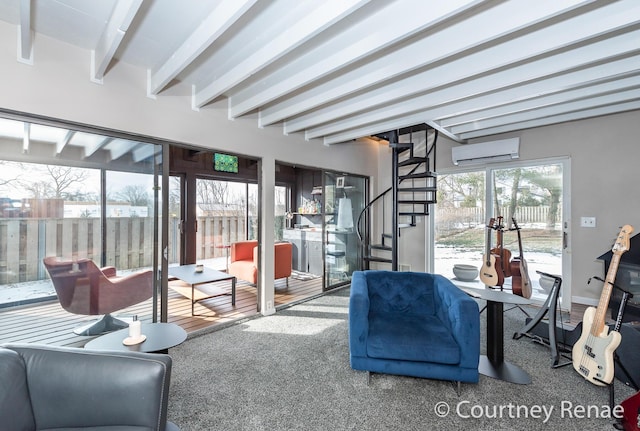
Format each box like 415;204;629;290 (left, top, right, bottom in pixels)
229;240;293;287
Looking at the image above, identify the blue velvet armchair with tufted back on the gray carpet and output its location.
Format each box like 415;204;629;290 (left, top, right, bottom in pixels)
349;270;480;383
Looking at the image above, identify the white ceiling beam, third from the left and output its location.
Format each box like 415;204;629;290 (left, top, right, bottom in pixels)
147;0;257;96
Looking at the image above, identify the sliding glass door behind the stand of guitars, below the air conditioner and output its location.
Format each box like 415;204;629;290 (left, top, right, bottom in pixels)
434;162;566;308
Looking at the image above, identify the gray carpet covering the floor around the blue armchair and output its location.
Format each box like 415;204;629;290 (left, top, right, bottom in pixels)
169;289;634;431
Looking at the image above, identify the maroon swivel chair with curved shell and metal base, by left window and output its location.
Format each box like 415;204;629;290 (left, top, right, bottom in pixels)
43;256;153;335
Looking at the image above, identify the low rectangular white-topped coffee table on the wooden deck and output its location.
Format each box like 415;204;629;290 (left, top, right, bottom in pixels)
169;265;236;316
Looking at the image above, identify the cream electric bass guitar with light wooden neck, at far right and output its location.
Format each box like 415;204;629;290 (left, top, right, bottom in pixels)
572;225;633;386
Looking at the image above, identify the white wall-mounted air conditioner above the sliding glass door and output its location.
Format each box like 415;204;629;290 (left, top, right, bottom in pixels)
451;138;520;166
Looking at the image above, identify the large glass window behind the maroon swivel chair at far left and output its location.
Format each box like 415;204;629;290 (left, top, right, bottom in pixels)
0;118;161;305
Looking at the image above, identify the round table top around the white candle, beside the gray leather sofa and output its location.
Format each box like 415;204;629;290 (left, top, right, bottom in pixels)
84;323;187;353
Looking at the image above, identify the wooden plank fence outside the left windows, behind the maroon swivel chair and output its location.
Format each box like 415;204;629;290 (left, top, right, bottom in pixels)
0;216;246;284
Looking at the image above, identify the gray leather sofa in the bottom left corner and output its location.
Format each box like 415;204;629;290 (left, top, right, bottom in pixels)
0;344;178;431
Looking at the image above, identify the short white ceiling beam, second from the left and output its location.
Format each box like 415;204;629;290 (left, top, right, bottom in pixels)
91;0;142;83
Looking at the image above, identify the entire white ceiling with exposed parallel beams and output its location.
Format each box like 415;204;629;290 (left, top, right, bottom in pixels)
0;0;640;145
